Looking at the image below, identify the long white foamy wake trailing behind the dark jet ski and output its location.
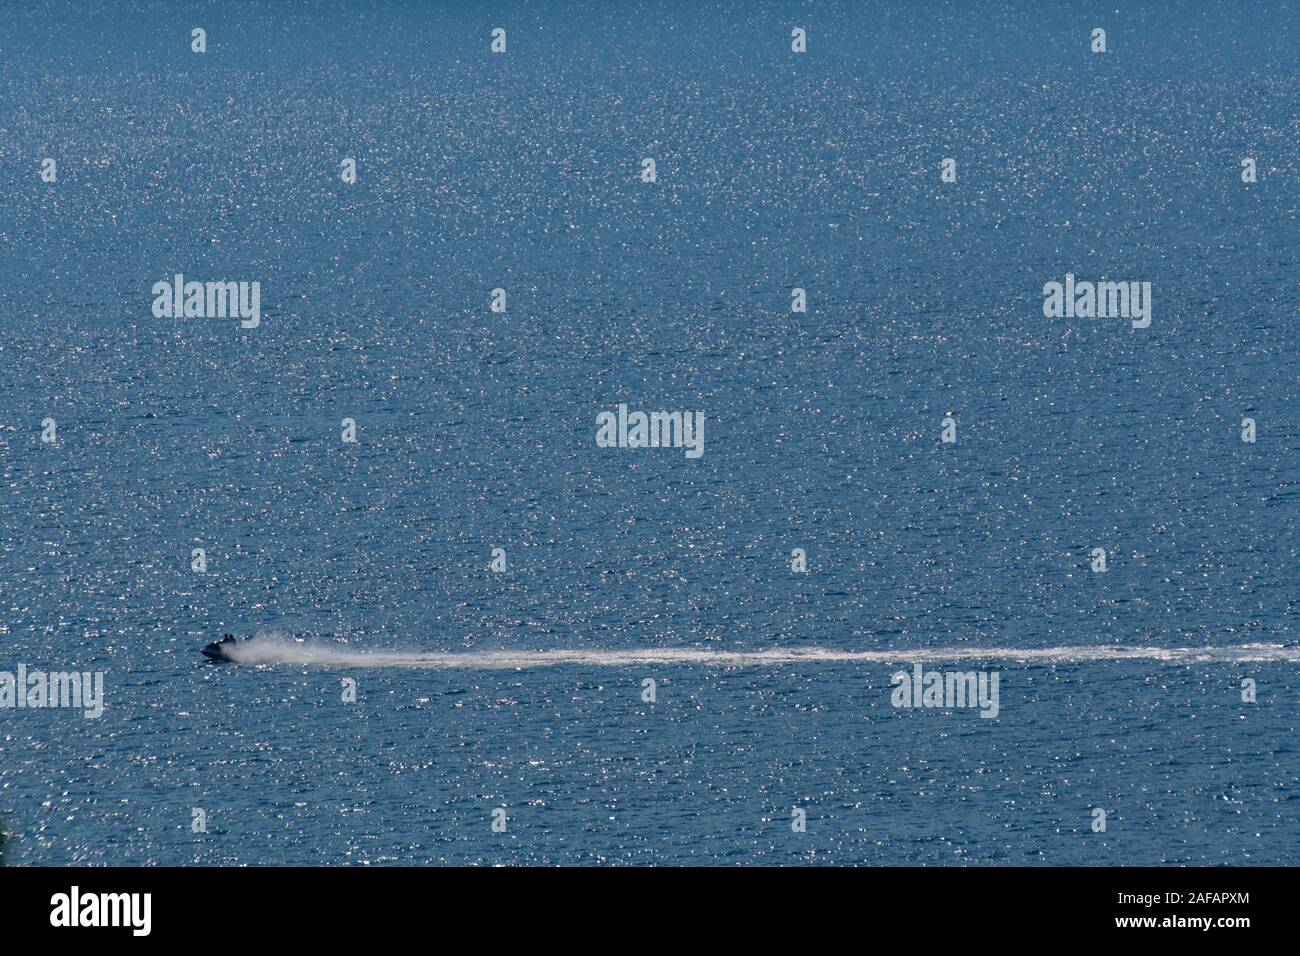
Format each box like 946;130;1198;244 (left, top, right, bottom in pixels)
229;637;1300;670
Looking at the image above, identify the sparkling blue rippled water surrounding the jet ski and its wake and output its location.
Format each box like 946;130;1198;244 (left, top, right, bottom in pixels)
0;3;1300;865
